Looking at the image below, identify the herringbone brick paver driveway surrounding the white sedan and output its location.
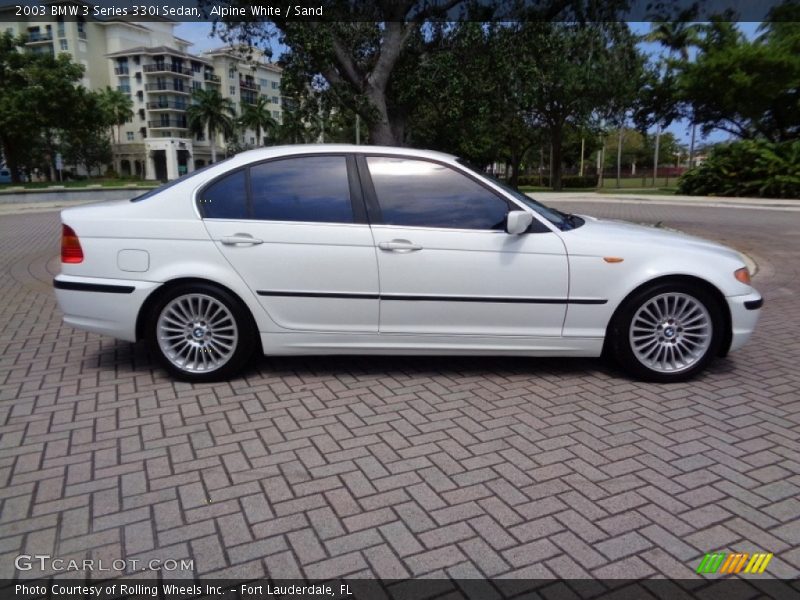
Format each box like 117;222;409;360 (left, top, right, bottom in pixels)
0;204;800;578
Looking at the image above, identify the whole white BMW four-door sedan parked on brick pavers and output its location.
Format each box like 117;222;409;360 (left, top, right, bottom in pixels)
54;145;762;382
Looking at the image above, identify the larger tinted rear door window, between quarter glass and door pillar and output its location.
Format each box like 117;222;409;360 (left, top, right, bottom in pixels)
250;156;353;223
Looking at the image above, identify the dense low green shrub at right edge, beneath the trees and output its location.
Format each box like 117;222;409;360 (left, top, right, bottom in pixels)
678;140;800;198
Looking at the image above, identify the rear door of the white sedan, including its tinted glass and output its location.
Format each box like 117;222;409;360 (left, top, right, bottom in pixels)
198;154;378;332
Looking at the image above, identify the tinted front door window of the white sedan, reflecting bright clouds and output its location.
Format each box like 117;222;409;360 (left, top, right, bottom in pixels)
367;156;508;229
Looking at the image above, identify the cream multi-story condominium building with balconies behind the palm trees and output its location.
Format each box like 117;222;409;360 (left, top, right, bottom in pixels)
0;13;283;180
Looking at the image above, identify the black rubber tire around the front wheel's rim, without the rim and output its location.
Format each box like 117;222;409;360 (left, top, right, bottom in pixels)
610;282;725;383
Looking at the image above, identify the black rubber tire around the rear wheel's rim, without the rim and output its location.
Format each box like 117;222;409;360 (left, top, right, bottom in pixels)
146;282;256;382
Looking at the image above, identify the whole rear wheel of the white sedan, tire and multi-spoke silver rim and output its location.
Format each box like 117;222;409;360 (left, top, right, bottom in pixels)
146;283;257;383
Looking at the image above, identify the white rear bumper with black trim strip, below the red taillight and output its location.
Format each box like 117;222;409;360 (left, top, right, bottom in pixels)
53;275;161;342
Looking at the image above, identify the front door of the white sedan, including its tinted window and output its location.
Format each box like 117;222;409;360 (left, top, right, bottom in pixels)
362;156;569;337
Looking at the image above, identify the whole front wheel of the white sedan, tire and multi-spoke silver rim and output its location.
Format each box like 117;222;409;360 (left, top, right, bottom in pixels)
609;282;725;383
